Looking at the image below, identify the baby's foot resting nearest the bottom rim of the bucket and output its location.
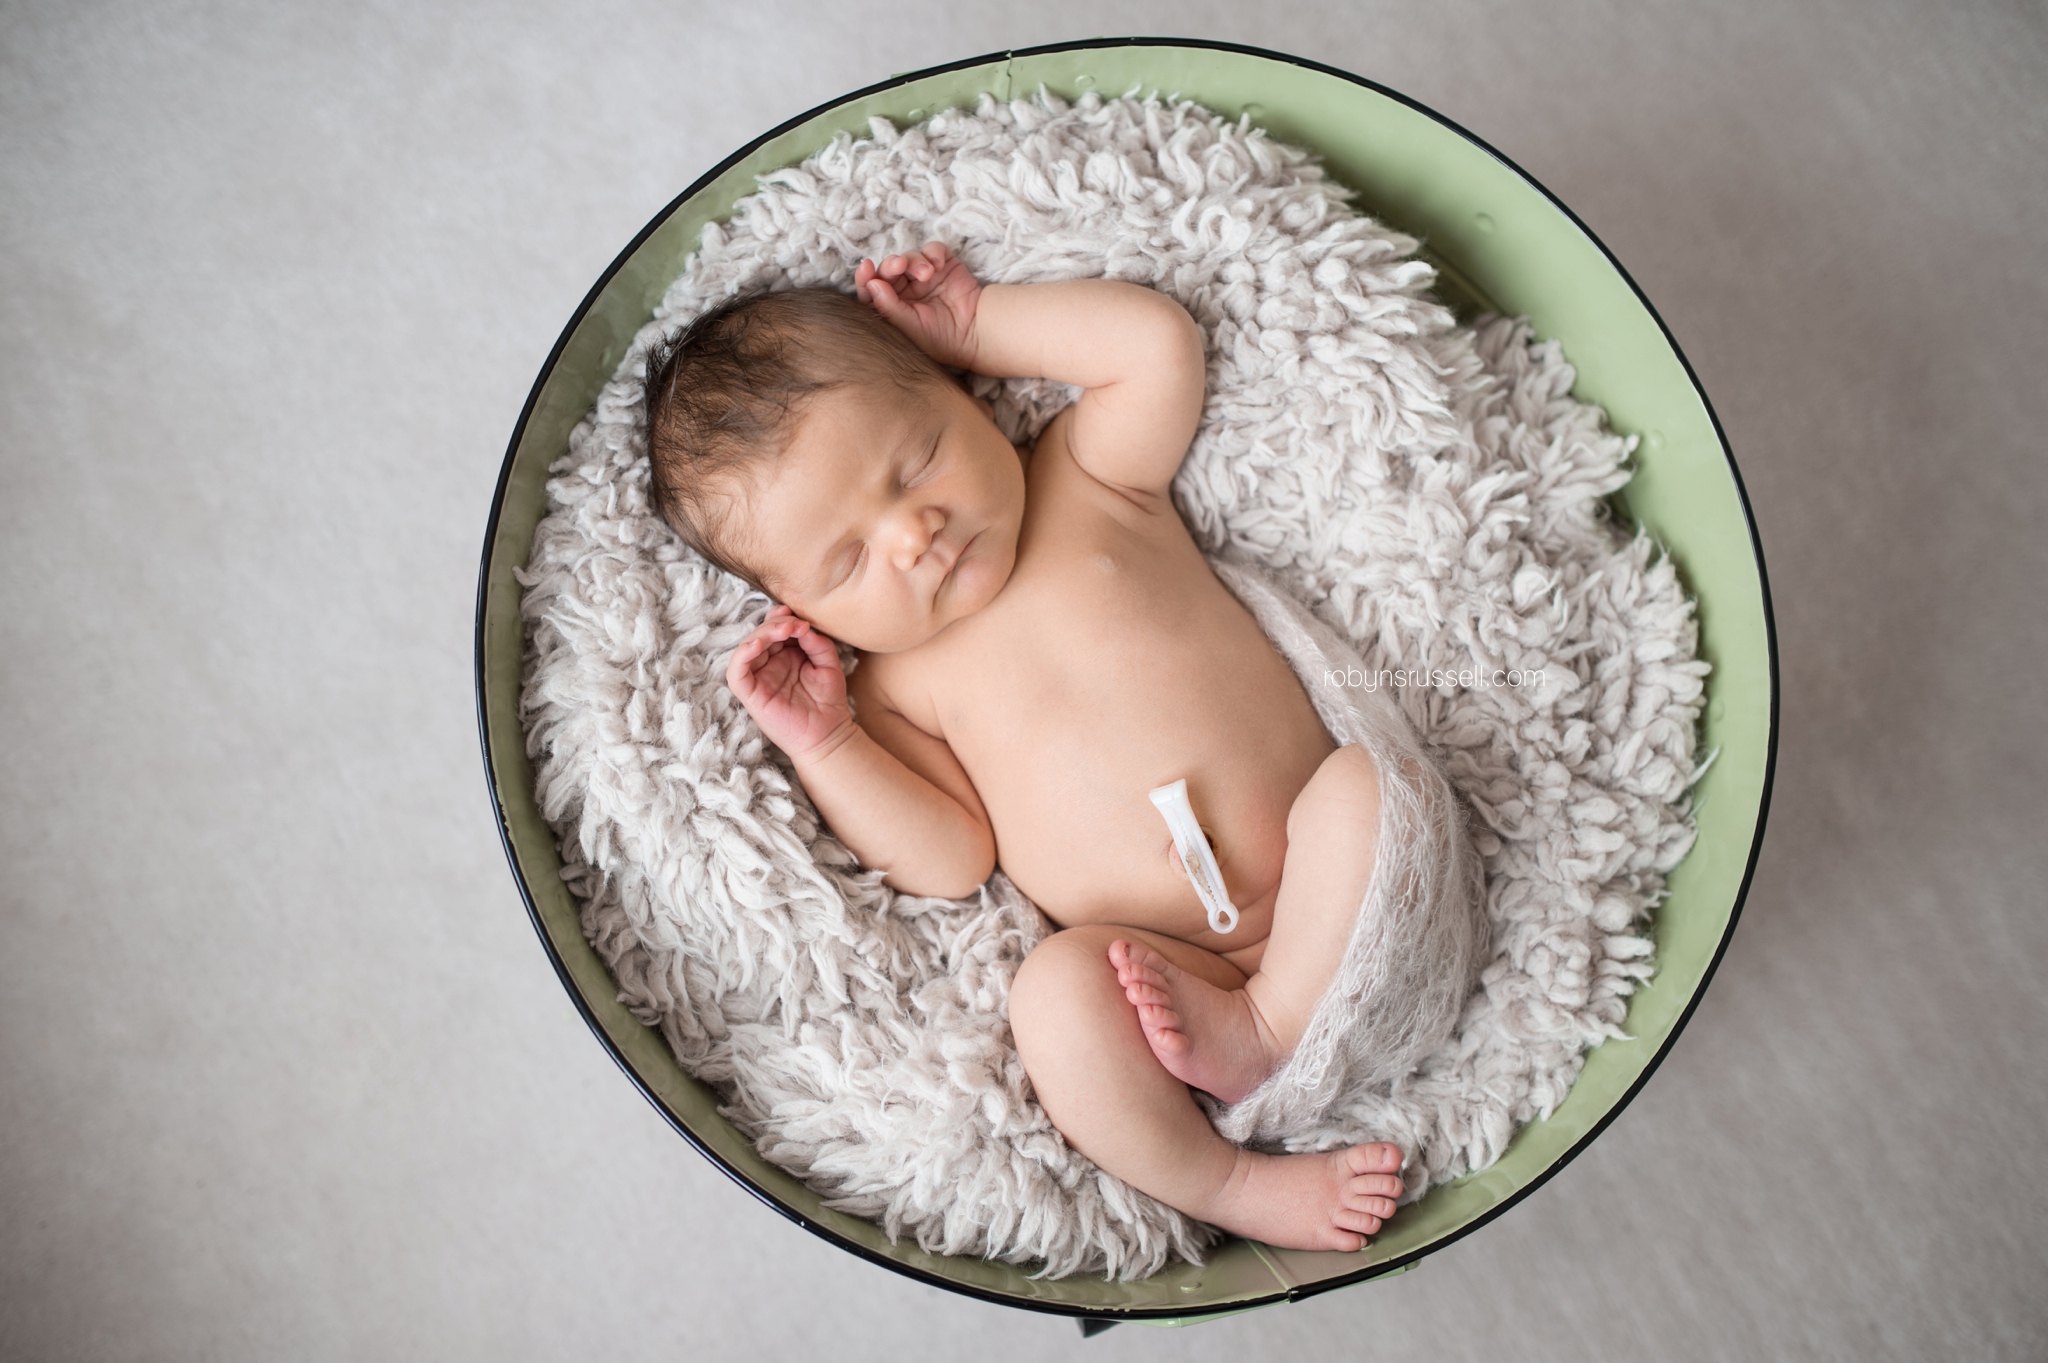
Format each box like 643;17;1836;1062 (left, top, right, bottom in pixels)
1194;1142;1403;1250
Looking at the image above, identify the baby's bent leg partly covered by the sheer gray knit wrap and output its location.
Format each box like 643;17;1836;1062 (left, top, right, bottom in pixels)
1110;743;1380;1103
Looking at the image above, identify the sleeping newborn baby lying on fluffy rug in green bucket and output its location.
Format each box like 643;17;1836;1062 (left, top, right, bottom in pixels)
647;244;1462;1250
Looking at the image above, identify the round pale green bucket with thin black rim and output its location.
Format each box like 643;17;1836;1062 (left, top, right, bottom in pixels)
477;39;1778;1324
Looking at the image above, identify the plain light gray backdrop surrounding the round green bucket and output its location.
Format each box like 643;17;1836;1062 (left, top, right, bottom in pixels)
0;0;2048;1361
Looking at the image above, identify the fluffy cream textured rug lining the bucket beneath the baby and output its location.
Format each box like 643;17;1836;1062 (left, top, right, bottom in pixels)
522;96;1706;1277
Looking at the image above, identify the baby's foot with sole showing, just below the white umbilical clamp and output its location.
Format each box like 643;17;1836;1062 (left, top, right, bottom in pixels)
1110;939;1286;1103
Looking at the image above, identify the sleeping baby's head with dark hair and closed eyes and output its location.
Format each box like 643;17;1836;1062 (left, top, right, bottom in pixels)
647;289;1024;653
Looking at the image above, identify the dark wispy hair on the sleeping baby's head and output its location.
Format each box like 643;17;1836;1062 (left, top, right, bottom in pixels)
647;289;948;591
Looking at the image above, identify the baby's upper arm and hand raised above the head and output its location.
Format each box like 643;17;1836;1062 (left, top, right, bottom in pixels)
854;241;1204;505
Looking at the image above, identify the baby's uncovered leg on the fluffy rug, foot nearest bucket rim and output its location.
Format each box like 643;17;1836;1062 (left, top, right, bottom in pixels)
1010;927;1401;1250
